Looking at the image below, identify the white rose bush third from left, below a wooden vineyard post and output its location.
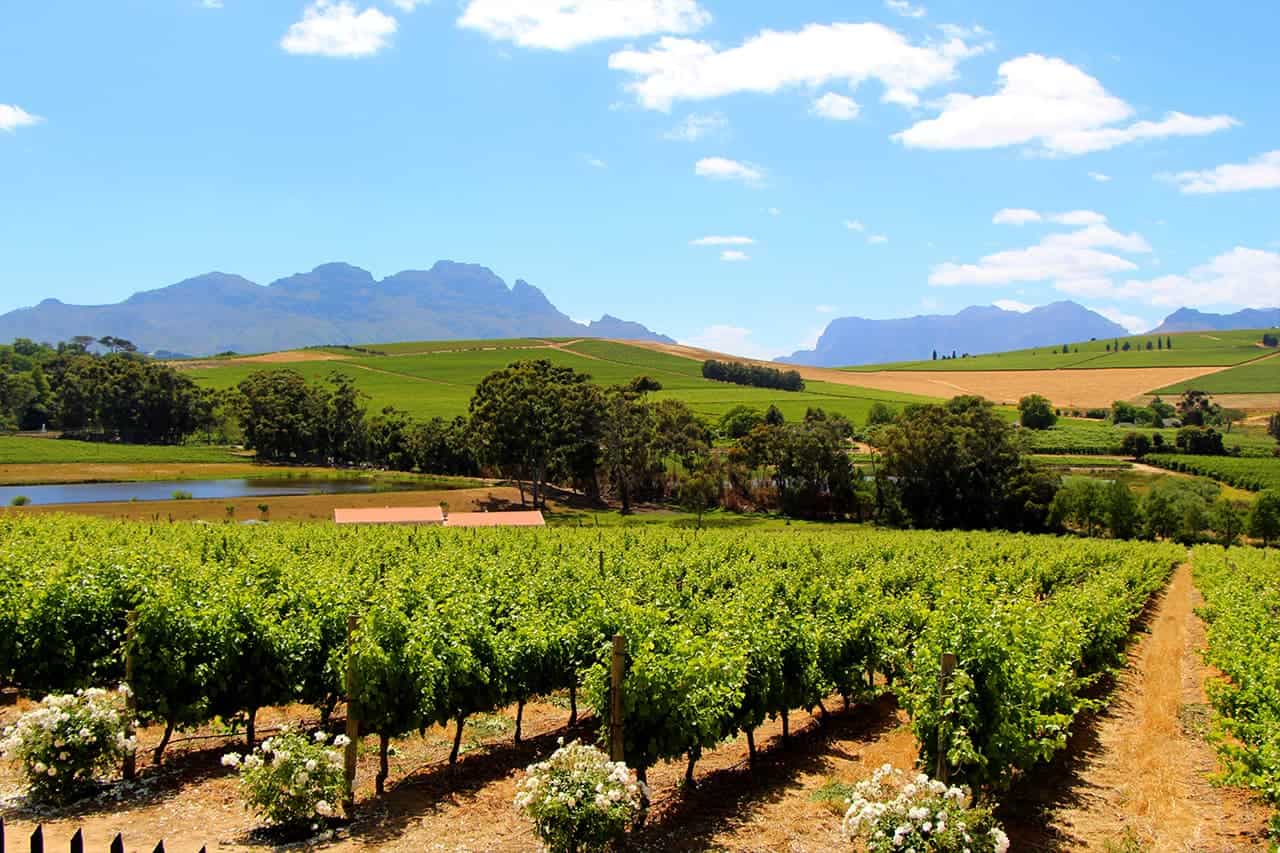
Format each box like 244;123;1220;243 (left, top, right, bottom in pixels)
515;738;649;853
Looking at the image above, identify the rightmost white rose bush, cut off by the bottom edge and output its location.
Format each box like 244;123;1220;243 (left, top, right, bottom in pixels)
844;765;1009;853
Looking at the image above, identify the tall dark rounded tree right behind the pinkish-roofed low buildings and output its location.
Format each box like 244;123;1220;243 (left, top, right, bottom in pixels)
471;360;590;506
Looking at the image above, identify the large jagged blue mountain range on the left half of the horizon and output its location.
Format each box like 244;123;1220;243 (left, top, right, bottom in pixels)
0;261;675;355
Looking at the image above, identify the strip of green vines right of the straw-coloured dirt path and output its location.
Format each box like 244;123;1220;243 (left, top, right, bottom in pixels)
1193;546;1280;833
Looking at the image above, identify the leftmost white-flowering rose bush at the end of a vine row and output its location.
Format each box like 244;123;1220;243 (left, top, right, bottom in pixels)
0;685;133;803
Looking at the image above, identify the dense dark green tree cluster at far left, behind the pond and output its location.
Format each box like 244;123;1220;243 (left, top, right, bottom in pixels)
0;336;218;443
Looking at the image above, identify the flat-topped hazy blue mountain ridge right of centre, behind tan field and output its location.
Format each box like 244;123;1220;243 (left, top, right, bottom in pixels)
778;301;1129;368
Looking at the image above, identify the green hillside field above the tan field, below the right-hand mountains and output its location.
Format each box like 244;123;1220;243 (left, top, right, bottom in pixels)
846;329;1267;373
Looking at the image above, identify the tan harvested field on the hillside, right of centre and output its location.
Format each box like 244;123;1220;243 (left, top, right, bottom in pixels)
627;341;1224;409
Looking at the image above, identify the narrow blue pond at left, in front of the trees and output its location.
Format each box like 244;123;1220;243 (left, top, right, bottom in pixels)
0;478;421;506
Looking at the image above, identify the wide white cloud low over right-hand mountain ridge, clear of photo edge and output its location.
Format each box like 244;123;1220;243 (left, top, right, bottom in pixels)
929;223;1151;289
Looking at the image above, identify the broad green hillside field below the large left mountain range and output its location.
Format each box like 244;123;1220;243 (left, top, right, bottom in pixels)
189;341;929;424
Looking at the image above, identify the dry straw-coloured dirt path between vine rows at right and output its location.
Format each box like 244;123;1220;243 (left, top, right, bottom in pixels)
1011;565;1267;853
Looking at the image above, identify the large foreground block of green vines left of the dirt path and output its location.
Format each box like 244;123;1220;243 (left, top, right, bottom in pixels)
0;517;1180;804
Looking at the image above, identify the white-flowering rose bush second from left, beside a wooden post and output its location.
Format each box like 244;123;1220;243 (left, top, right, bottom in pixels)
223;730;348;826
